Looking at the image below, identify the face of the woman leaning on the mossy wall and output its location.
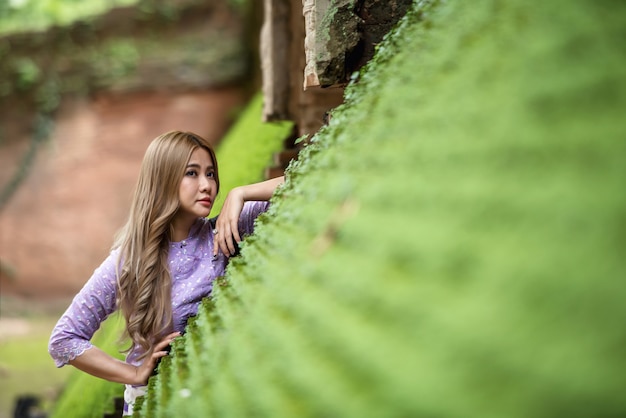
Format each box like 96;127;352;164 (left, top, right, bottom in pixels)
176;147;217;225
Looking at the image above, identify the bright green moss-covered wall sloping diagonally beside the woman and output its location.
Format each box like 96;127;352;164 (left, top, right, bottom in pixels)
137;0;626;418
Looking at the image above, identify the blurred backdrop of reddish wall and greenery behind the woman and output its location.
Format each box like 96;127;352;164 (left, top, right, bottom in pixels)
0;0;260;418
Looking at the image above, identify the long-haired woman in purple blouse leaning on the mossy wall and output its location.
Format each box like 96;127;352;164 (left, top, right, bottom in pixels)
49;131;283;415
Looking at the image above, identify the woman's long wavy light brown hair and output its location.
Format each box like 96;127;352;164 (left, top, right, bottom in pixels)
114;131;220;358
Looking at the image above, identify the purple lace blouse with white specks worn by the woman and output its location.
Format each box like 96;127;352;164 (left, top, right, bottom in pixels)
48;202;269;367
